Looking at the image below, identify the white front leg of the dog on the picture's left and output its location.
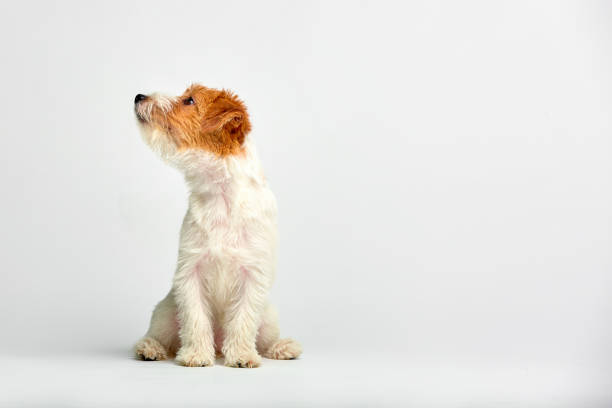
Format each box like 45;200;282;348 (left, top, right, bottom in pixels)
173;239;215;367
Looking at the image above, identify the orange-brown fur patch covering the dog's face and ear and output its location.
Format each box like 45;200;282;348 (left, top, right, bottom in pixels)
151;85;251;157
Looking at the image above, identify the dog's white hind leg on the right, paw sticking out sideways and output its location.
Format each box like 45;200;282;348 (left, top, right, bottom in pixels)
257;303;302;360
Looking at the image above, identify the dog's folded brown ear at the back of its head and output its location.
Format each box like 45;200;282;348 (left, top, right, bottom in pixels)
200;91;251;154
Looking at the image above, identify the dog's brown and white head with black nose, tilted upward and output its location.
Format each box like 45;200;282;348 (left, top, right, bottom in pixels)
134;85;251;163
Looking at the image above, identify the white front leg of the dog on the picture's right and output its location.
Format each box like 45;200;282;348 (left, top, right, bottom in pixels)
222;267;269;368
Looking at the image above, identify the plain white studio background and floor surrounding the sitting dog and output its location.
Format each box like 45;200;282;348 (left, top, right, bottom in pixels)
0;1;612;407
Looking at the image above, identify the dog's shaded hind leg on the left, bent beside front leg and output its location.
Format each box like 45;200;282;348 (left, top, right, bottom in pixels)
134;291;180;360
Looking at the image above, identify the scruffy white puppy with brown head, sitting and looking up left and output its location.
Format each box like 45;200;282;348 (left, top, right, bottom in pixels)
134;85;302;368
